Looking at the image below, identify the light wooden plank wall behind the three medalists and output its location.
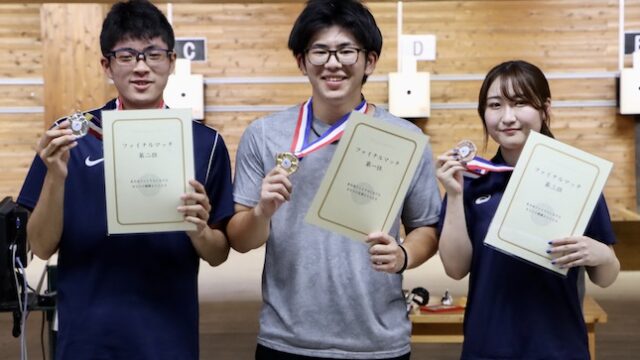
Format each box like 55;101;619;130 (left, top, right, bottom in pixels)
0;0;640;220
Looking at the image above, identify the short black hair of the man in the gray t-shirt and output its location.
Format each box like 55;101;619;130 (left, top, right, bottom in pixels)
289;0;382;57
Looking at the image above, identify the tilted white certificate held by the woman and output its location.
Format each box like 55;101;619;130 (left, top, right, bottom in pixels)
484;132;613;275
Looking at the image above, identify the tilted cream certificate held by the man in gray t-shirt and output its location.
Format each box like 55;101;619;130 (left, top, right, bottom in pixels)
305;112;427;241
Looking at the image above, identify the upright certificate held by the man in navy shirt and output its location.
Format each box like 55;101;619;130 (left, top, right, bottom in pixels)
102;109;196;234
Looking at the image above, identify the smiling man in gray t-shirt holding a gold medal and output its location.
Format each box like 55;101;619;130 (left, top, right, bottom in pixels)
227;0;440;360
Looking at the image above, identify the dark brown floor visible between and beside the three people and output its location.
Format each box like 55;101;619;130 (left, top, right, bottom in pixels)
0;300;640;360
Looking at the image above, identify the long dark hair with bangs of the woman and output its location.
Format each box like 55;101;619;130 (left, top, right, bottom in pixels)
478;60;553;146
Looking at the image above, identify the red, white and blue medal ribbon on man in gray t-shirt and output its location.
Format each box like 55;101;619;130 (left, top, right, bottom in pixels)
291;98;369;159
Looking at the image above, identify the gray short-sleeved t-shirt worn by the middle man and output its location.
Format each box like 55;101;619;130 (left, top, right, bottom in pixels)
234;106;440;359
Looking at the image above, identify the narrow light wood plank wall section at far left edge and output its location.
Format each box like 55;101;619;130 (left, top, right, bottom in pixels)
0;4;44;198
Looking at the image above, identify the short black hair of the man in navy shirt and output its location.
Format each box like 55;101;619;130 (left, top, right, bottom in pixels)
100;0;176;55
